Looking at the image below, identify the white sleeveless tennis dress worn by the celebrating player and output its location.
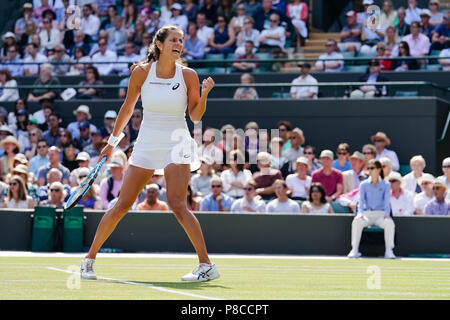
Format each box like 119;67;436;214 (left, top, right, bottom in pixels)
129;61;200;171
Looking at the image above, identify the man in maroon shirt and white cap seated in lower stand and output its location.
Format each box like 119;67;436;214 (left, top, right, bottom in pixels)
311;150;344;202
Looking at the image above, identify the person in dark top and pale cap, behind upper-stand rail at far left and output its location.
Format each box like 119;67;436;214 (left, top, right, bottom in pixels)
27;63;61;101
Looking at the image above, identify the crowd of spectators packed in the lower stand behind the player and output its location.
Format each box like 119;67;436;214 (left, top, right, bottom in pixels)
0;104;450;216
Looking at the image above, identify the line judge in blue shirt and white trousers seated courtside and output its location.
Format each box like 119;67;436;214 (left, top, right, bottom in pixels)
347;159;395;259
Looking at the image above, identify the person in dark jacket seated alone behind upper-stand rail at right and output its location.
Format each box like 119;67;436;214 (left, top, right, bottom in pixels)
350;60;388;98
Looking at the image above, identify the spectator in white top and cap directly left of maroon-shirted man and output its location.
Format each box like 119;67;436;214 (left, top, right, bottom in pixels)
286;157;312;200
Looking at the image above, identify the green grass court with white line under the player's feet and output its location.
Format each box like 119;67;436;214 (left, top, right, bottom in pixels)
0;252;450;300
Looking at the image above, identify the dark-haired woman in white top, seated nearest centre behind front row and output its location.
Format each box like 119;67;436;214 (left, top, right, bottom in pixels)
220;150;252;199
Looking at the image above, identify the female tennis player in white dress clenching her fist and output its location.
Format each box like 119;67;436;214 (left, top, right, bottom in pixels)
80;26;219;281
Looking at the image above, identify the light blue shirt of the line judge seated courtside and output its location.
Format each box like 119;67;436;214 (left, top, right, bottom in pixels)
358;177;391;216
